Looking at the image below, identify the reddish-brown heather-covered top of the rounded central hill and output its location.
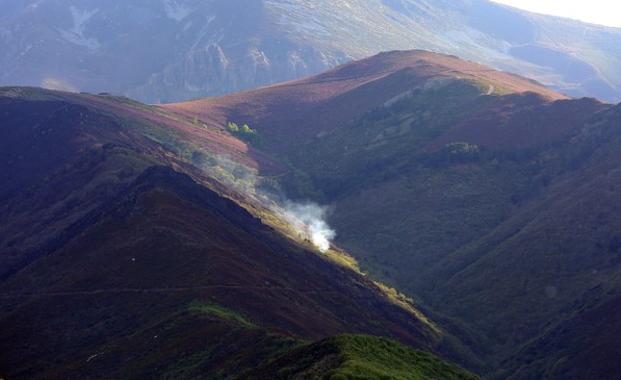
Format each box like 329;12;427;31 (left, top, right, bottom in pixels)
162;51;565;152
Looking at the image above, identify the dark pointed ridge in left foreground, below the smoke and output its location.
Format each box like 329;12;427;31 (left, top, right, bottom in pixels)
0;168;438;378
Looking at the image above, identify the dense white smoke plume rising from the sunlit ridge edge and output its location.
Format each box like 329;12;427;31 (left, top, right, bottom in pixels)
284;201;336;252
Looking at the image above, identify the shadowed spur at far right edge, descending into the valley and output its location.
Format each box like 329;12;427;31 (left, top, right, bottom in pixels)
425;106;621;379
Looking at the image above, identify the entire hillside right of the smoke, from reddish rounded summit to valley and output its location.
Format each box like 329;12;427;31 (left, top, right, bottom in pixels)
164;51;621;378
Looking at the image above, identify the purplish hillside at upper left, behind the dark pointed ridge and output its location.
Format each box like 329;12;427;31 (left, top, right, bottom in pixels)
0;88;264;276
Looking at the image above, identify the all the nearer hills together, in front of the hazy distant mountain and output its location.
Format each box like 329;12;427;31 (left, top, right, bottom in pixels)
0;50;621;379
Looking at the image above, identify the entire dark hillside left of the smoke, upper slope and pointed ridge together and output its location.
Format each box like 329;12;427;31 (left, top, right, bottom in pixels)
0;88;472;379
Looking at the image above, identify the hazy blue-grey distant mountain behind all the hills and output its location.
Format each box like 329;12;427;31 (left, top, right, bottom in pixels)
0;0;621;102
